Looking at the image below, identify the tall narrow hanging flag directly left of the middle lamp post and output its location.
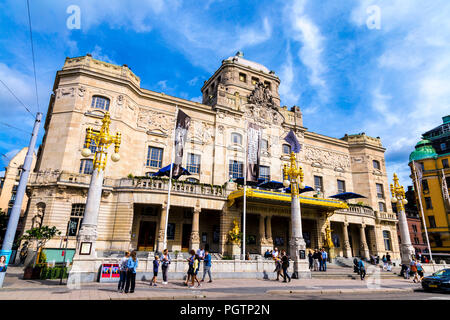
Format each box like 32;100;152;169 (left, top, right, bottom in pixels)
246;123;262;182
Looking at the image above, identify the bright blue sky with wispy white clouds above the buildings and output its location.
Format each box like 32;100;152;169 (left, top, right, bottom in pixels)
0;0;450;185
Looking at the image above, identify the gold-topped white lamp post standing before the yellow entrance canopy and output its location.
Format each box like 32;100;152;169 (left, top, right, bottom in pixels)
283;152;311;279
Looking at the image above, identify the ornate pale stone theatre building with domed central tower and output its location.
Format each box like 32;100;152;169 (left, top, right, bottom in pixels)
22;52;400;260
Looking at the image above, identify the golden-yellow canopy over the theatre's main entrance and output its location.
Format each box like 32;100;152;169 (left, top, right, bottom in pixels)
228;188;348;210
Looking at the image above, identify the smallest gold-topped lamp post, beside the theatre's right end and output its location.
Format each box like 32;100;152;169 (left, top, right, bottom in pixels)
391;173;415;265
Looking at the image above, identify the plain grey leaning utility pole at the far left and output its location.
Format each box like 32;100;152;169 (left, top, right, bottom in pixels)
0;112;42;288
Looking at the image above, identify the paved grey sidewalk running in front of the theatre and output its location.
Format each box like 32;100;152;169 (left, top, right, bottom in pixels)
0;268;420;300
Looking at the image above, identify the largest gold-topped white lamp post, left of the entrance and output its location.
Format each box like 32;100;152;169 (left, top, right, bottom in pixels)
69;112;121;282
